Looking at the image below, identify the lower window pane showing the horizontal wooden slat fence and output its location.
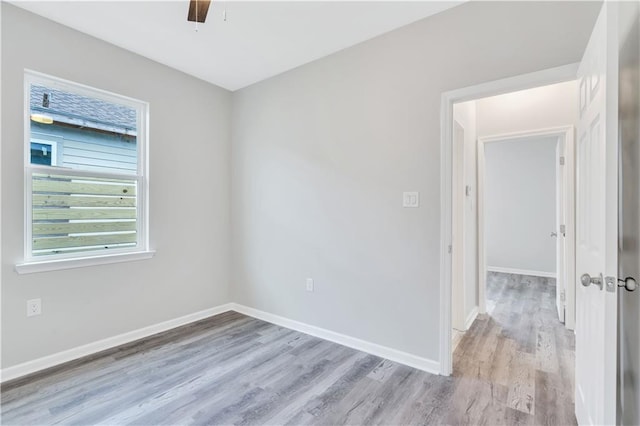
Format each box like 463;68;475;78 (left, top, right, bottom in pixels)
32;173;137;256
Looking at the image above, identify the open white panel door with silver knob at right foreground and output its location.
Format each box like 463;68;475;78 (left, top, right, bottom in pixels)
575;2;618;425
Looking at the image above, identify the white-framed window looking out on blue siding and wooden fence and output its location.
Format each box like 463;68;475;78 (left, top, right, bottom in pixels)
17;71;150;272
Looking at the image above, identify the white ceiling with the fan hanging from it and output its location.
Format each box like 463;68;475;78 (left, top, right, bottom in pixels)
12;0;462;90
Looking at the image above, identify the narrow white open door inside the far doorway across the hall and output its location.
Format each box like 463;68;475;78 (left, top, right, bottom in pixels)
552;138;567;322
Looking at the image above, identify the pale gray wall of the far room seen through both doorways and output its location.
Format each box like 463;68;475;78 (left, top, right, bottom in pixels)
484;137;557;274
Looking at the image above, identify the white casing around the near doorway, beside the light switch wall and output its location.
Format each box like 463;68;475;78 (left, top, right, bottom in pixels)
439;63;579;376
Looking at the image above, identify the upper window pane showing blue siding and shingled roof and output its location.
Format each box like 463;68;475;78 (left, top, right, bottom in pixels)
29;84;138;174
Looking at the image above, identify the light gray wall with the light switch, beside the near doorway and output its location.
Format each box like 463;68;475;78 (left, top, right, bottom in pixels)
231;2;600;360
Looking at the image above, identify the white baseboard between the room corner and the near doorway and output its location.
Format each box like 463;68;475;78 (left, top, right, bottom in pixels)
231;303;440;374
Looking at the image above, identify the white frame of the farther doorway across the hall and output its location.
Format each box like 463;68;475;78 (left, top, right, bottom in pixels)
477;125;576;330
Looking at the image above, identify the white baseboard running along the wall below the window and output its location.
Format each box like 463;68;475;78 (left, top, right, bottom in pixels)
0;303;232;383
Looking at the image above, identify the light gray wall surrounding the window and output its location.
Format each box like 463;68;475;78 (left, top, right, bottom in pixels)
1;3;231;368
